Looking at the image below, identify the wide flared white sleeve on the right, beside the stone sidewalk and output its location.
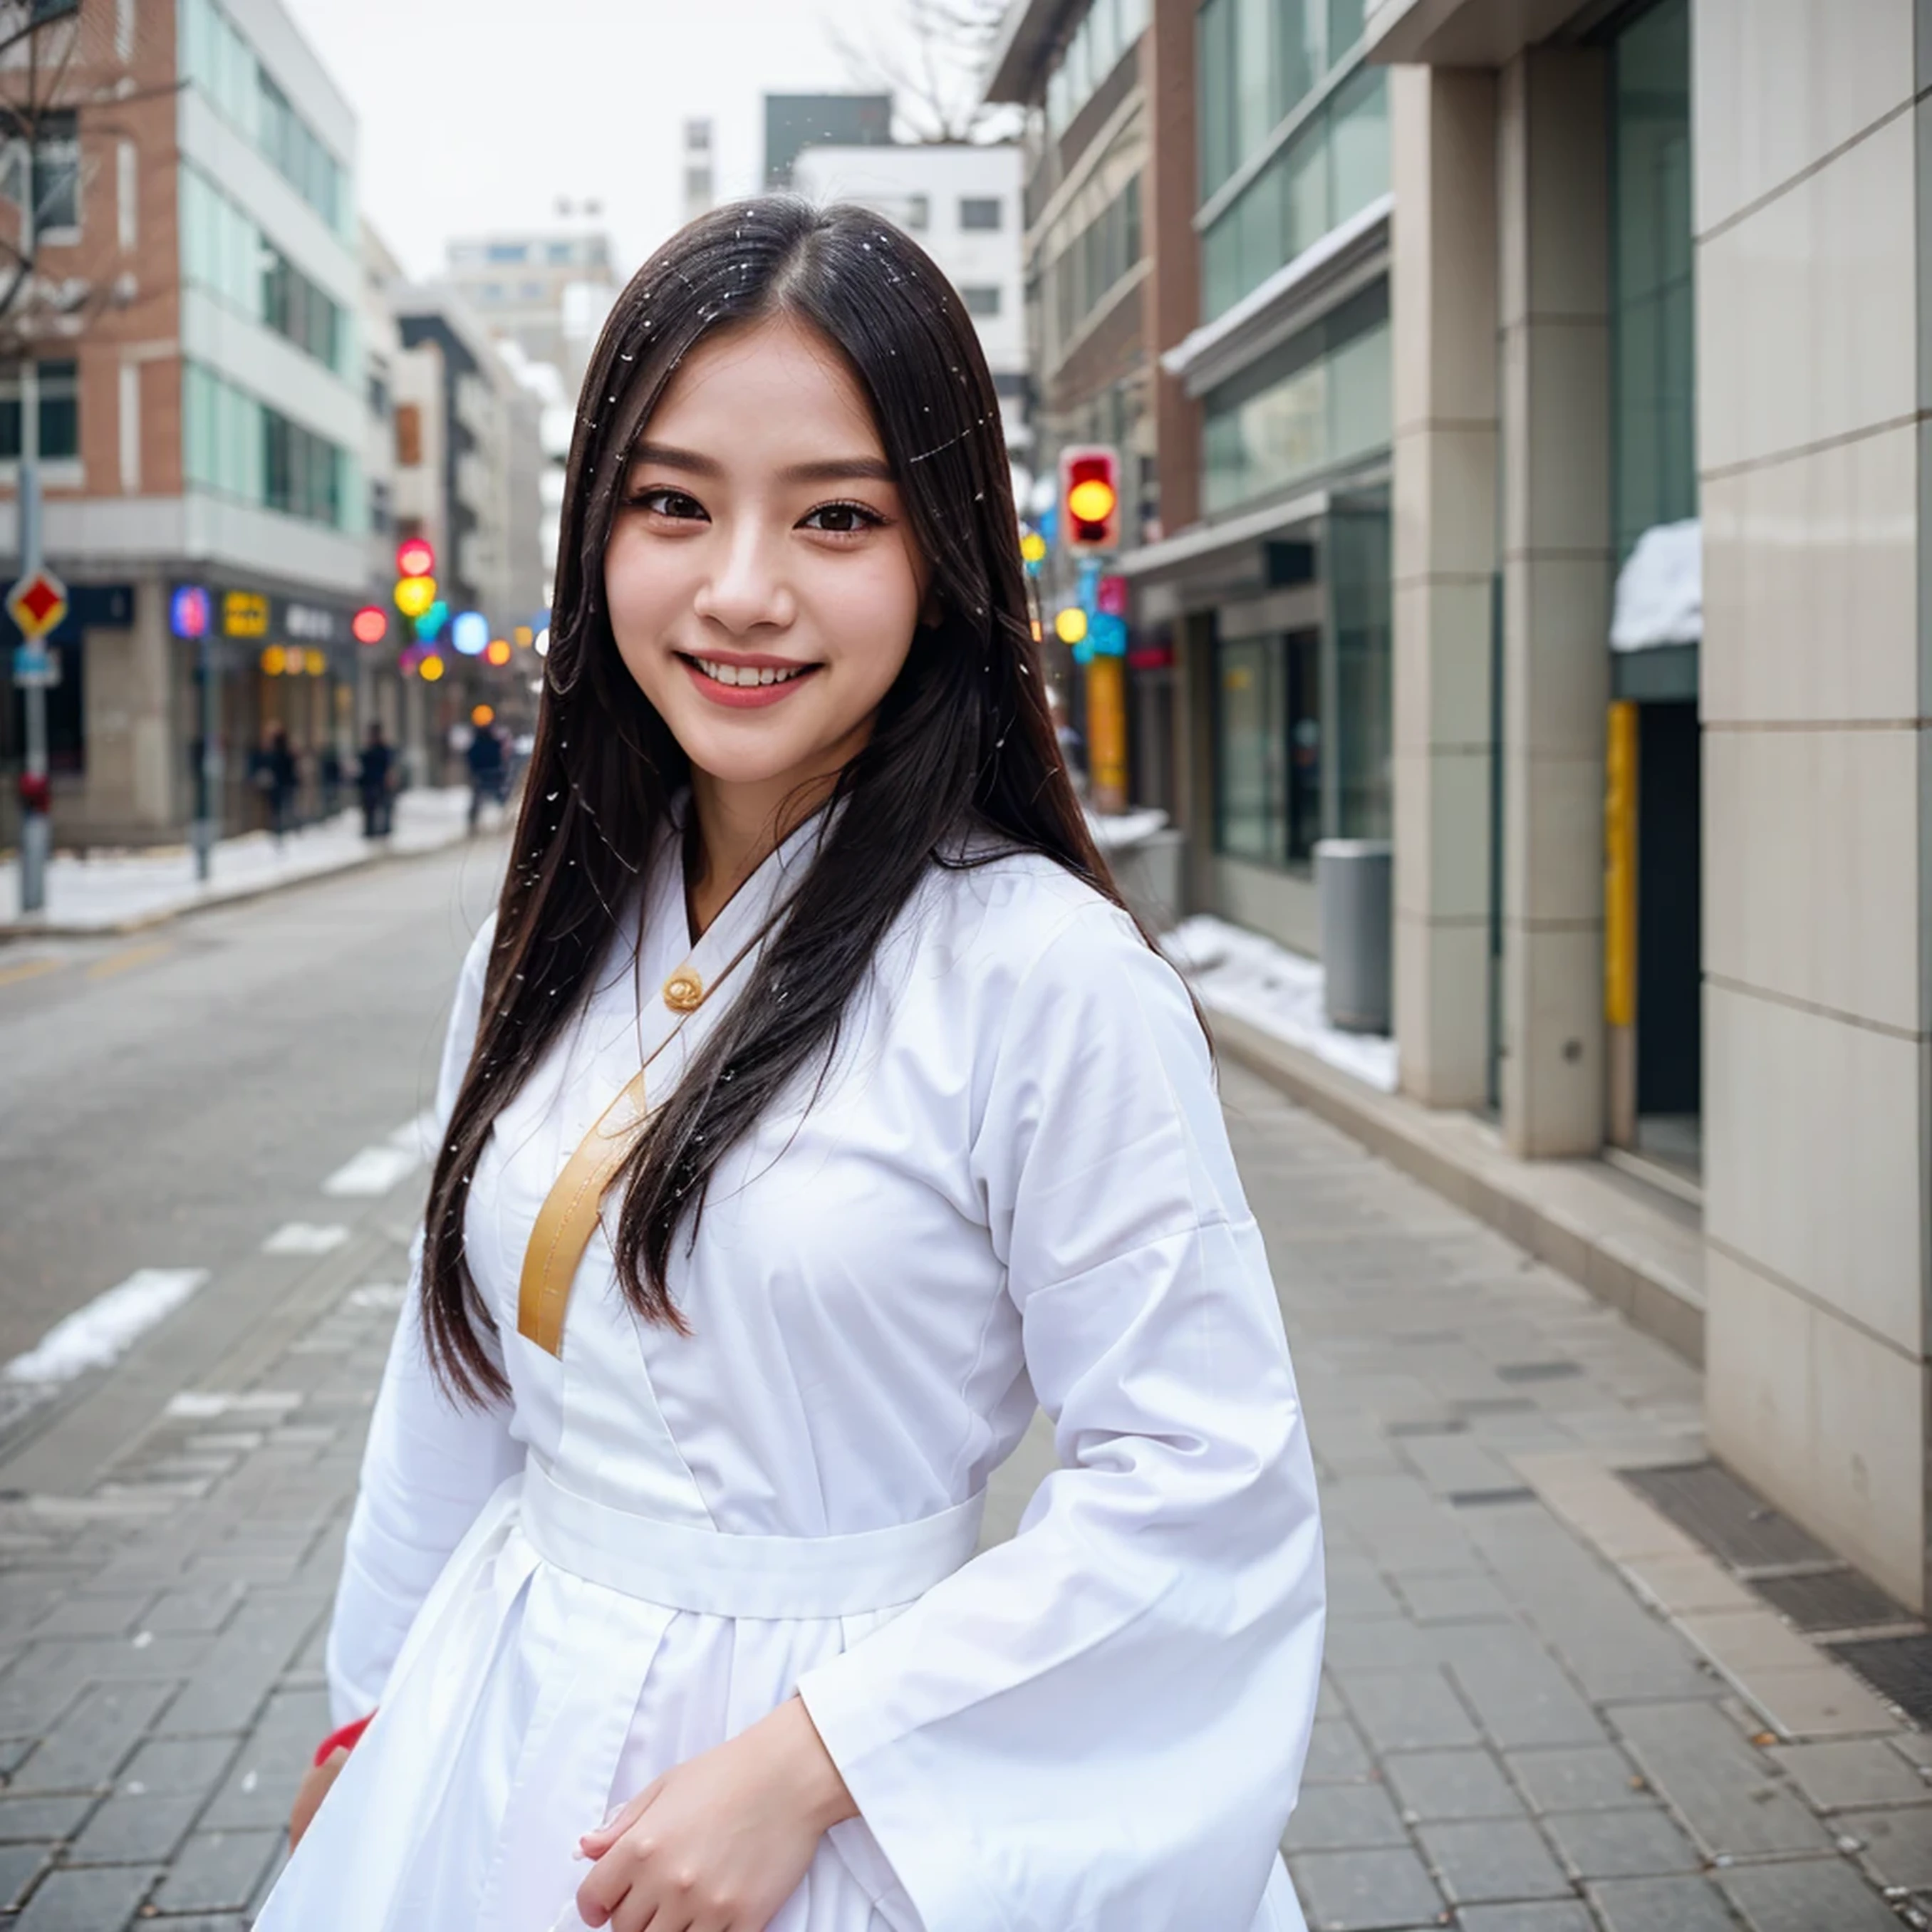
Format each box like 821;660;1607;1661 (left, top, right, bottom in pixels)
800;906;1324;1932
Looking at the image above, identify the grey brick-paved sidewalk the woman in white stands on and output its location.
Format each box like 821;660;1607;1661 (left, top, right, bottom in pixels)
0;1066;1932;1932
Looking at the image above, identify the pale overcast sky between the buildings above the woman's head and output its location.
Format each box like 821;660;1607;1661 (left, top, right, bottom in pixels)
288;0;958;276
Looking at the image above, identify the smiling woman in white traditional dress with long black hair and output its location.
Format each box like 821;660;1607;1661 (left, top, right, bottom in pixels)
259;201;1321;1932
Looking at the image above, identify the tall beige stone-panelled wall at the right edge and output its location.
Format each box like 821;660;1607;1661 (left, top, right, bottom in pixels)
1693;0;1932;1607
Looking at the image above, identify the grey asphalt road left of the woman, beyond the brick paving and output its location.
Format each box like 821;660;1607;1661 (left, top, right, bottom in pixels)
0;838;504;1362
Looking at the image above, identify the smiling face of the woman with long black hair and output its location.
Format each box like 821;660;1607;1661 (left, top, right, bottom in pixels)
605;318;929;794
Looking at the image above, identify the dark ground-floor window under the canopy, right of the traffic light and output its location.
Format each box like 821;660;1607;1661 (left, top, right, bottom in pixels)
1215;630;1321;866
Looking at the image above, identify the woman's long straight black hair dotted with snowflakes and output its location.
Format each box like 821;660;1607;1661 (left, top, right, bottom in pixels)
423;197;1121;1401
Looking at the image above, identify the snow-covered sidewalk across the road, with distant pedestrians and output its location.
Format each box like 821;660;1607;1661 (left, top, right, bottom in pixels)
0;786;483;939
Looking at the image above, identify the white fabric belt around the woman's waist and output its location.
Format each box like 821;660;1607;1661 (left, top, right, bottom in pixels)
521;1460;985;1619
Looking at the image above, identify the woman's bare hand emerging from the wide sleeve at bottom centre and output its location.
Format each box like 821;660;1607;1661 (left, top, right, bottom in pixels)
578;1696;858;1932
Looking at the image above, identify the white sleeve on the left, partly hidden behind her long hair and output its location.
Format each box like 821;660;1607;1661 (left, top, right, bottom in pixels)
328;918;524;1723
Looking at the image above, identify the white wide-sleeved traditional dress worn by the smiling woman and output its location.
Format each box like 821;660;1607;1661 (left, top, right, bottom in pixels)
257;811;1324;1932
